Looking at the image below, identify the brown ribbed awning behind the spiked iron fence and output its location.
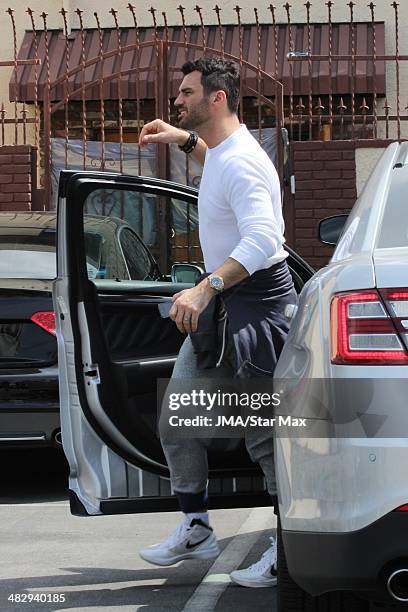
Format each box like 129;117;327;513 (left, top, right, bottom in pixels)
9;22;385;102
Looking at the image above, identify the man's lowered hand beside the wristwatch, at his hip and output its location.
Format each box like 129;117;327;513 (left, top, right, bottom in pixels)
169;279;215;334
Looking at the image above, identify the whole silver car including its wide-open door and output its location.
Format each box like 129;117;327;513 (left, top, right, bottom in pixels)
54;144;408;612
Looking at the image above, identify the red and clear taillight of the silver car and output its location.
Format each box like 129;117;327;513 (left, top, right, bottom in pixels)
330;289;408;365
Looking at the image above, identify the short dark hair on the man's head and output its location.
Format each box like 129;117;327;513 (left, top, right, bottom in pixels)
181;57;240;113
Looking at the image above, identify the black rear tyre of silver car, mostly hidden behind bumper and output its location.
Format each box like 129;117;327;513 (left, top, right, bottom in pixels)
277;522;370;612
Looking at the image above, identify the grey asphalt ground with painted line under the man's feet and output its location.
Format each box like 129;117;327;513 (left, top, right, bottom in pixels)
0;450;276;612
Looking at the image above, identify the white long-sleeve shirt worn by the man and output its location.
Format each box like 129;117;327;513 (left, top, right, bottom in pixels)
198;125;287;274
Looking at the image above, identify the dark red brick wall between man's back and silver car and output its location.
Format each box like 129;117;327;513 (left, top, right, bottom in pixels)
291;141;357;269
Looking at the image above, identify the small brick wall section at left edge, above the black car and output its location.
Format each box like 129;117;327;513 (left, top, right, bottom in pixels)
0;145;37;211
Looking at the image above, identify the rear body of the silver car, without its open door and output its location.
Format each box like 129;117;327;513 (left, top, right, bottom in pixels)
275;143;408;612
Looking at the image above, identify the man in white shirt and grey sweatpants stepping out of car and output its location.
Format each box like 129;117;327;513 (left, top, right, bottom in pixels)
140;58;296;586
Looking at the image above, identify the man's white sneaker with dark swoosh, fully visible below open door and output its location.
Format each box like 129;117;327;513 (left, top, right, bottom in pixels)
139;519;220;565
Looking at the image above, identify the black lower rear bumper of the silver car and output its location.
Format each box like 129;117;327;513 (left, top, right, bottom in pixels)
282;512;408;595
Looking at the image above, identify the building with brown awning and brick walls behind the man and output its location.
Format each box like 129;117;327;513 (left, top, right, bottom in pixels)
0;0;408;267
